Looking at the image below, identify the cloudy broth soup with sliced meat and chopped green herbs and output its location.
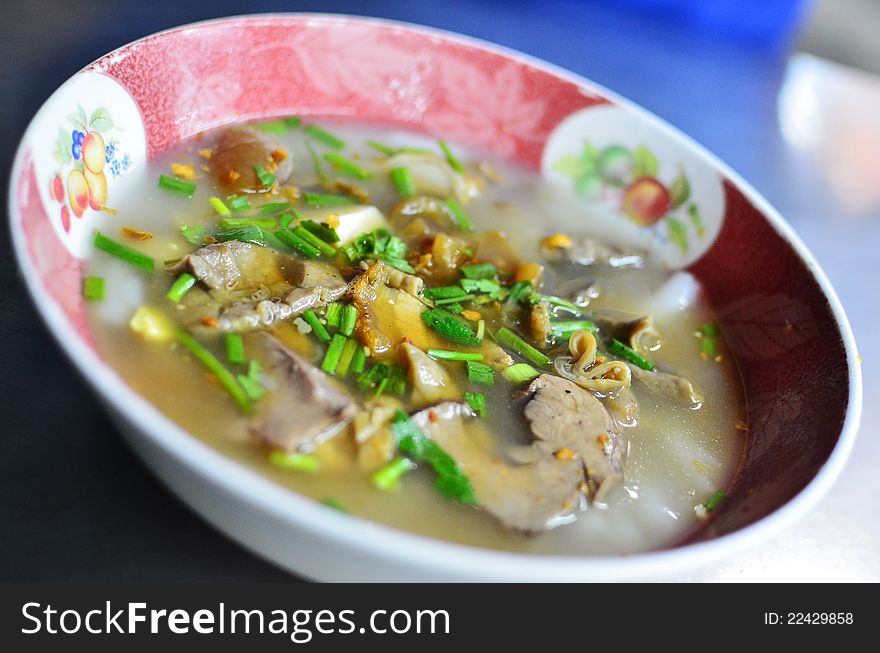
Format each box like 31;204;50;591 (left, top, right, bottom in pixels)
84;119;744;555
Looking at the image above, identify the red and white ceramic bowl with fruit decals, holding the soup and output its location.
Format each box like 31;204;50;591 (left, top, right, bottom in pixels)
9;15;861;581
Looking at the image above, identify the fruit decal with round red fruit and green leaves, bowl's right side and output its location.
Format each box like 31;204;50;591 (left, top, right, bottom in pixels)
552;141;705;254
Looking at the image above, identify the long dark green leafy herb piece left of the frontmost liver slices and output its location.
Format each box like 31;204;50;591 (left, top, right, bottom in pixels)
391;410;477;505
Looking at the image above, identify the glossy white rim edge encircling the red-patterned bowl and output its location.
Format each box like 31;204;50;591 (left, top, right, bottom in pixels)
8;13;862;581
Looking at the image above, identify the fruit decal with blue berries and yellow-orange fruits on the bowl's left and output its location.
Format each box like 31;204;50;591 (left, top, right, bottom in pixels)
49;106;131;232
